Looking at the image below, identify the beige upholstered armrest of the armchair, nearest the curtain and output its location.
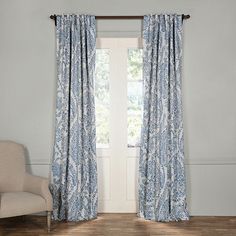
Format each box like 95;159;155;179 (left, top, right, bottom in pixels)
24;173;52;211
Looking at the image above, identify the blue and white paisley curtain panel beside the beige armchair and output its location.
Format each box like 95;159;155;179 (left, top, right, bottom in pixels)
52;15;97;221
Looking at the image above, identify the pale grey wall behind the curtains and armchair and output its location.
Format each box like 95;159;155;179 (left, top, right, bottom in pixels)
0;0;236;215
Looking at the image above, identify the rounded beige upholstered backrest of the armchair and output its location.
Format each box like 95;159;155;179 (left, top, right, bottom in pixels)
0;141;25;192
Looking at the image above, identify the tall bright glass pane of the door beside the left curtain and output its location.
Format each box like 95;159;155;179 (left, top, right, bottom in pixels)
95;49;110;147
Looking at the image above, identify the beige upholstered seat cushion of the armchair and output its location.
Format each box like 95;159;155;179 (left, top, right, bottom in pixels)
0;192;46;218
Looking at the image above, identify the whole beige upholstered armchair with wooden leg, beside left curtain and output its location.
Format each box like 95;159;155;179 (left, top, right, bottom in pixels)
0;141;52;231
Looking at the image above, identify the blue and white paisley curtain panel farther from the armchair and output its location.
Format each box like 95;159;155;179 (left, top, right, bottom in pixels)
139;15;189;221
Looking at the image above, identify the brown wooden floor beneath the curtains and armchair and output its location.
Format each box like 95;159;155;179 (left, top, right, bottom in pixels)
0;214;236;236
